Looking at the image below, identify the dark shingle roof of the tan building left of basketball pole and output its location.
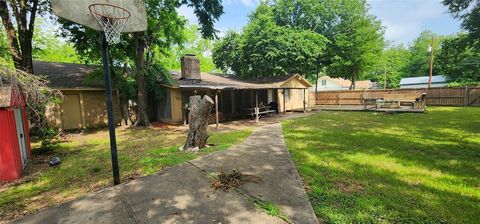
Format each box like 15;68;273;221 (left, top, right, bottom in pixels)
33;61;104;89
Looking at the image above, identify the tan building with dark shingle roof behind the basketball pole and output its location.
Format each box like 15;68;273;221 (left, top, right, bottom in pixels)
33;61;121;130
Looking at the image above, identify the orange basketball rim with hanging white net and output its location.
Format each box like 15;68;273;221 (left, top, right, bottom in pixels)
88;4;131;44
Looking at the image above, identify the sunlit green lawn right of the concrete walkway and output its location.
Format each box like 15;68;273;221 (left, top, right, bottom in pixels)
283;107;480;223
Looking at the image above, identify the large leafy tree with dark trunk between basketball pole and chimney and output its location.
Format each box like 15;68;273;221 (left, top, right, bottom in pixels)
60;0;223;126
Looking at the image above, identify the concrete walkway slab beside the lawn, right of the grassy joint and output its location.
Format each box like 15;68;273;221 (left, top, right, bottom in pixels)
191;123;318;223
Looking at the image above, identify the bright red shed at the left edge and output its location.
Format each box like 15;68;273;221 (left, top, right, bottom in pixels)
0;86;31;181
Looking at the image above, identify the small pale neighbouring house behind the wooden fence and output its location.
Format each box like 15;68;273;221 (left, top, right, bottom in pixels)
309;75;374;92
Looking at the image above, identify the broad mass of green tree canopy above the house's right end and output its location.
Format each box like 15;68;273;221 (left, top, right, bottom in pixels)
213;0;384;89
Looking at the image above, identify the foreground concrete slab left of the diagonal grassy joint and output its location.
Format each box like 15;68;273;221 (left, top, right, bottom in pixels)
14;163;284;224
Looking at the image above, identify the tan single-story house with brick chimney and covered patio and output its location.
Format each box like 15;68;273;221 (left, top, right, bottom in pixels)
150;57;312;123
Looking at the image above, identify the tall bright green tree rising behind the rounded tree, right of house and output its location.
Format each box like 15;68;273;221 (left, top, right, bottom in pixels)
256;0;384;88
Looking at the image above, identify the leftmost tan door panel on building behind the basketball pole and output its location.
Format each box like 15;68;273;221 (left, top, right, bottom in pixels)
61;94;82;129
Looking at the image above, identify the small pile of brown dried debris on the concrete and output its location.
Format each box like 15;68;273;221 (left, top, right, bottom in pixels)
211;169;263;191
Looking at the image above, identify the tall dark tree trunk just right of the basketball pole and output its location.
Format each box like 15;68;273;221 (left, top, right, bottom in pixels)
134;32;150;126
